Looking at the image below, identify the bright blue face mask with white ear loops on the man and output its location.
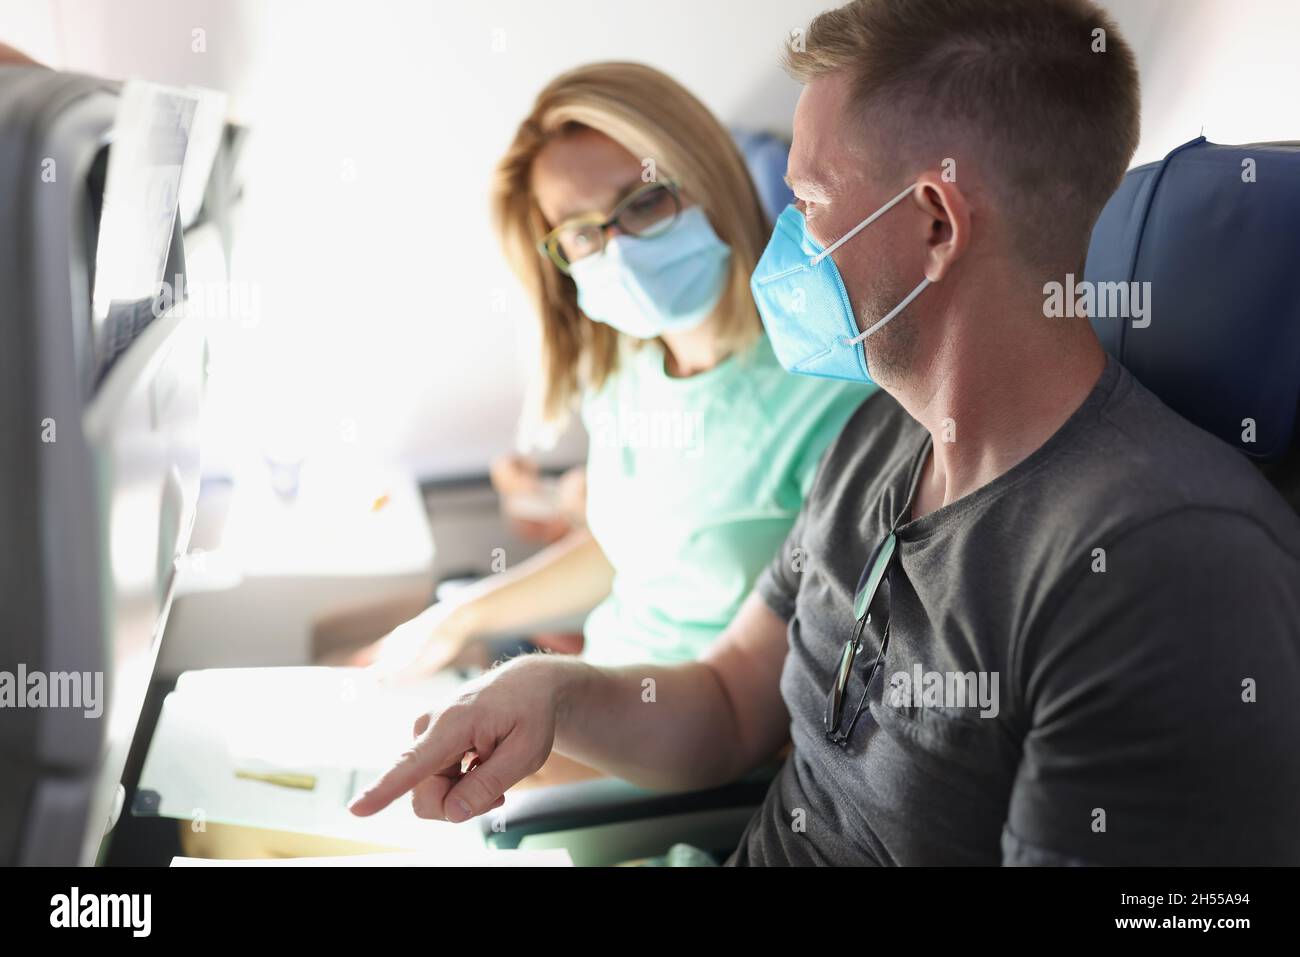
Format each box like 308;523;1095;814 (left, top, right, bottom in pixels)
749;186;930;382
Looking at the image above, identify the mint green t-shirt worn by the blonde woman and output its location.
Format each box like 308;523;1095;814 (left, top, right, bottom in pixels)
582;335;875;664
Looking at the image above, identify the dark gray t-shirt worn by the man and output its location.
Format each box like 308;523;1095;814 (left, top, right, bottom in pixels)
731;360;1300;865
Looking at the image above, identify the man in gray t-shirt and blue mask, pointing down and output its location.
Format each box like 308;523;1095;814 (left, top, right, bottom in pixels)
354;0;1300;865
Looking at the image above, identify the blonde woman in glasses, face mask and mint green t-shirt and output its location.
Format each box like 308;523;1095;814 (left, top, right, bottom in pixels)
373;62;870;674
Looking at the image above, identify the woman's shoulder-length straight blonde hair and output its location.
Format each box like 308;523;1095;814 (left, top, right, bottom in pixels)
491;62;768;428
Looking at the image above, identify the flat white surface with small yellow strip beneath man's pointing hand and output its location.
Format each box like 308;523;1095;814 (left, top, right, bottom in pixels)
137;667;484;849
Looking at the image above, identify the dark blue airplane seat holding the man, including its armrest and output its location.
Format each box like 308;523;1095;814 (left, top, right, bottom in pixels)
482;138;1300;865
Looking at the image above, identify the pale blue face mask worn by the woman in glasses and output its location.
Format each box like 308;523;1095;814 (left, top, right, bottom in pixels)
569;205;731;339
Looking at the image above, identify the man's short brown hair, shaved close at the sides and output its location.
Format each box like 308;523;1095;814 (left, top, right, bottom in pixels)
785;0;1140;269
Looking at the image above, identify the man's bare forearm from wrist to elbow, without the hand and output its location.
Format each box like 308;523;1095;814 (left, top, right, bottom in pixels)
545;658;754;791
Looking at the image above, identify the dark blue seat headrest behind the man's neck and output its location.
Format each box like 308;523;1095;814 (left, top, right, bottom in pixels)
1084;137;1300;462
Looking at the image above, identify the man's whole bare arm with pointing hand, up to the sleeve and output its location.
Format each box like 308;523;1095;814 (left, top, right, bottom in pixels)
351;598;790;822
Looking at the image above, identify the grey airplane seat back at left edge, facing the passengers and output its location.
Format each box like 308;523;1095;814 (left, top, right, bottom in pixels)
0;65;203;865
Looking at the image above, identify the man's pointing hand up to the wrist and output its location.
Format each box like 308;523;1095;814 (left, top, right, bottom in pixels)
350;655;572;823
